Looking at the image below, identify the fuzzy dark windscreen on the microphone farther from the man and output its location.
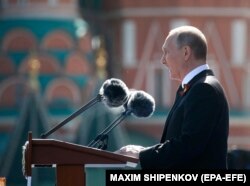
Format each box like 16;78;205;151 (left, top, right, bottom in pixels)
99;78;129;107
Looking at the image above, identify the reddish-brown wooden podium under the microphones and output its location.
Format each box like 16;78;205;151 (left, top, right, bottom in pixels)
23;132;138;186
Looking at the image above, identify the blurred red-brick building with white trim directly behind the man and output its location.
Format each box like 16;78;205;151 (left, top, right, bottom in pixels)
95;0;250;149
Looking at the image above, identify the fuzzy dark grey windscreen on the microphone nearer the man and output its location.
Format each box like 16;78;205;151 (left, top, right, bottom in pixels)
127;90;155;117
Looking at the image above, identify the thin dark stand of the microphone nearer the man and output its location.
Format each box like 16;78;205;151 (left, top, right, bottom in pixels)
88;111;131;150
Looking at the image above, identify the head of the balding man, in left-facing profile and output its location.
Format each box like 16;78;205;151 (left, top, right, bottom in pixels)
161;26;207;81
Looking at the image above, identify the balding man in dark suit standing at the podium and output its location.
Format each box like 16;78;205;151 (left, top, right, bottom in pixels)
118;26;229;169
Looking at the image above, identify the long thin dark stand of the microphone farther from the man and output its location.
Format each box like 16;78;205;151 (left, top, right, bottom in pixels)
41;94;103;139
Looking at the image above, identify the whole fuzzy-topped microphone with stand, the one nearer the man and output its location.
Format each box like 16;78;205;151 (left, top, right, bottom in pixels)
88;90;155;150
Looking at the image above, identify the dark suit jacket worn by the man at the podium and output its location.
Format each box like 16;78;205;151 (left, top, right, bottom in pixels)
139;70;229;170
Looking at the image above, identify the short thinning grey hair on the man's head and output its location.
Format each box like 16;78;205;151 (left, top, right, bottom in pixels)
169;26;207;60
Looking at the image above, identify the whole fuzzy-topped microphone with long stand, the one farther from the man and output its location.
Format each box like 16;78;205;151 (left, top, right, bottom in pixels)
41;78;129;138
